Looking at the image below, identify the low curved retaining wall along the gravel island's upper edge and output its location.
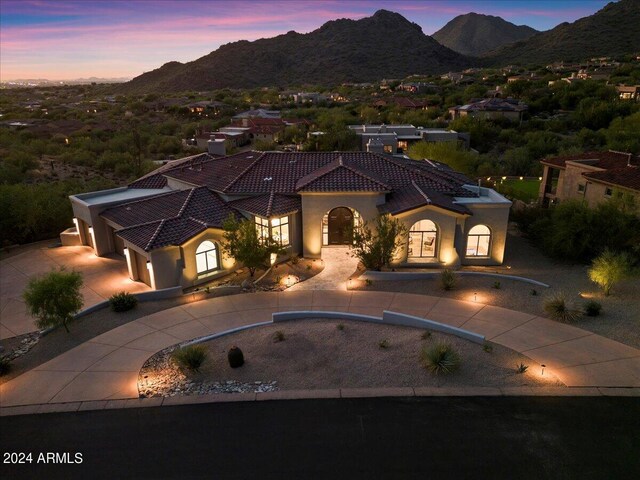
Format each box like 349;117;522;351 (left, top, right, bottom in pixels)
271;310;484;344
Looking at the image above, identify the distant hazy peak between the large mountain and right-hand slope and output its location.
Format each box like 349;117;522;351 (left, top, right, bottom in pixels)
432;12;539;57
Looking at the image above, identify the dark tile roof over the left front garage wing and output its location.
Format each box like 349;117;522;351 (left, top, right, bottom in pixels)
109;187;241;252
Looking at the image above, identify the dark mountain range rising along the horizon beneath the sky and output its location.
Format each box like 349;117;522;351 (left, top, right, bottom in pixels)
116;0;640;93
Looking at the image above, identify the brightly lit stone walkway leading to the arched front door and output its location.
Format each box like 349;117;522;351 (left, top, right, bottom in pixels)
288;247;359;292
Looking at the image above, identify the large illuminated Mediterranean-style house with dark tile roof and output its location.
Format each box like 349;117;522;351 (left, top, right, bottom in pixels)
70;151;511;289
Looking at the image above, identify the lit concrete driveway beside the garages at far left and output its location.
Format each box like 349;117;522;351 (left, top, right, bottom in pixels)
0;247;150;339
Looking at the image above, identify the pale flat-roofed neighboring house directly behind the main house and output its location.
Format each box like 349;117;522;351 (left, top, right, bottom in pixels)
349;125;469;154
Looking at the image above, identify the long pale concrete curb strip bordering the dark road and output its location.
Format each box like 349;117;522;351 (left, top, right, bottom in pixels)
0;387;640;417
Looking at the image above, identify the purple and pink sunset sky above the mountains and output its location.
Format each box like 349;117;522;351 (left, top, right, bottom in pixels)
0;0;608;81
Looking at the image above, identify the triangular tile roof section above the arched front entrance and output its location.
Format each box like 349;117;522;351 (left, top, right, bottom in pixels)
296;155;391;192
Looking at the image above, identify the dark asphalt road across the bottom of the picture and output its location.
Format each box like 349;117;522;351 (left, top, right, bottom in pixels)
0;397;640;480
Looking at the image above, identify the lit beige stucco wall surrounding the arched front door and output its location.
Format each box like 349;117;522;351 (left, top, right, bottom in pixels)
302;192;384;258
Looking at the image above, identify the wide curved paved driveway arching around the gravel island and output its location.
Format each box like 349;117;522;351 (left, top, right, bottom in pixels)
0;290;640;407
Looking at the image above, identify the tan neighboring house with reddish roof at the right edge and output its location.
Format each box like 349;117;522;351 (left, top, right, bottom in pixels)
539;151;640;207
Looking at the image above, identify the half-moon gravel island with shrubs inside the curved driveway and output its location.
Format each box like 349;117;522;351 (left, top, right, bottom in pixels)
138;319;563;396
